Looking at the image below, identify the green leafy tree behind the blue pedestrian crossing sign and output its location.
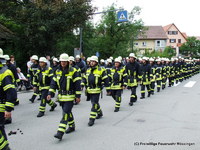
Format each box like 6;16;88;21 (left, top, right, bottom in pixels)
84;4;143;58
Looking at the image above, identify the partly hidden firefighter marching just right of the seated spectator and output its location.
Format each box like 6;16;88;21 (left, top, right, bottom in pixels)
27;55;40;103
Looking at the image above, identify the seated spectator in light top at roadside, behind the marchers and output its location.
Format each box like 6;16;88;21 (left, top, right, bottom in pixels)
17;68;31;91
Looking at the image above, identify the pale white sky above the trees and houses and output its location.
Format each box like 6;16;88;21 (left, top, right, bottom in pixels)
92;0;200;36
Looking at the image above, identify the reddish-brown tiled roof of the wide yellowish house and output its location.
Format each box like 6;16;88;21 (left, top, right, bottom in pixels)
138;26;168;40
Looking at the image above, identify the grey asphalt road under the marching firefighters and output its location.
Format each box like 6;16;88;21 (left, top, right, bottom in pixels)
6;75;200;150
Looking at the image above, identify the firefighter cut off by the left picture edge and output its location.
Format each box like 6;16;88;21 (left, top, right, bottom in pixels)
0;48;17;150
